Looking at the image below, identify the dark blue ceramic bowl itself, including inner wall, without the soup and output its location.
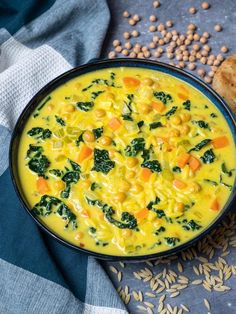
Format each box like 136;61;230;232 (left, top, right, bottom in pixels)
10;59;236;261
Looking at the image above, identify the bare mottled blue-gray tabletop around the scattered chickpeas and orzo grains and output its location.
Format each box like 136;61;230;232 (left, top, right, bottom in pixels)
102;0;236;314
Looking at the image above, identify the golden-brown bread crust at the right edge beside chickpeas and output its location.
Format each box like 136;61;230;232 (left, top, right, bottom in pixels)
212;54;236;112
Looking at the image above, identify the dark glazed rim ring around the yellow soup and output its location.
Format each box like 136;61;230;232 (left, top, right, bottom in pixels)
9;58;236;262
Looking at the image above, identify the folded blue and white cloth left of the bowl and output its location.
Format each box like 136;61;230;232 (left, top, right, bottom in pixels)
0;0;127;314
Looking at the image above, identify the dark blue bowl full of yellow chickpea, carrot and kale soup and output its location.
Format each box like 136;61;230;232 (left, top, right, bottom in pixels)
10;59;236;260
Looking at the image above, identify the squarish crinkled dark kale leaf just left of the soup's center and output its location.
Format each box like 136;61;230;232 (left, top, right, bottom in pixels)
92;148;115;174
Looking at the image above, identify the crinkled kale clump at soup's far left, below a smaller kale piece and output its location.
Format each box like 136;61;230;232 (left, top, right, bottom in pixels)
26;144;50;179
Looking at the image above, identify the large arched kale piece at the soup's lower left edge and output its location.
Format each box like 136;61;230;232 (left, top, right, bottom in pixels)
32;195;77;230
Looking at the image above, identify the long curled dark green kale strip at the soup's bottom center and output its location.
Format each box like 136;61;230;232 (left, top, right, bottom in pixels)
86;197;138;230
